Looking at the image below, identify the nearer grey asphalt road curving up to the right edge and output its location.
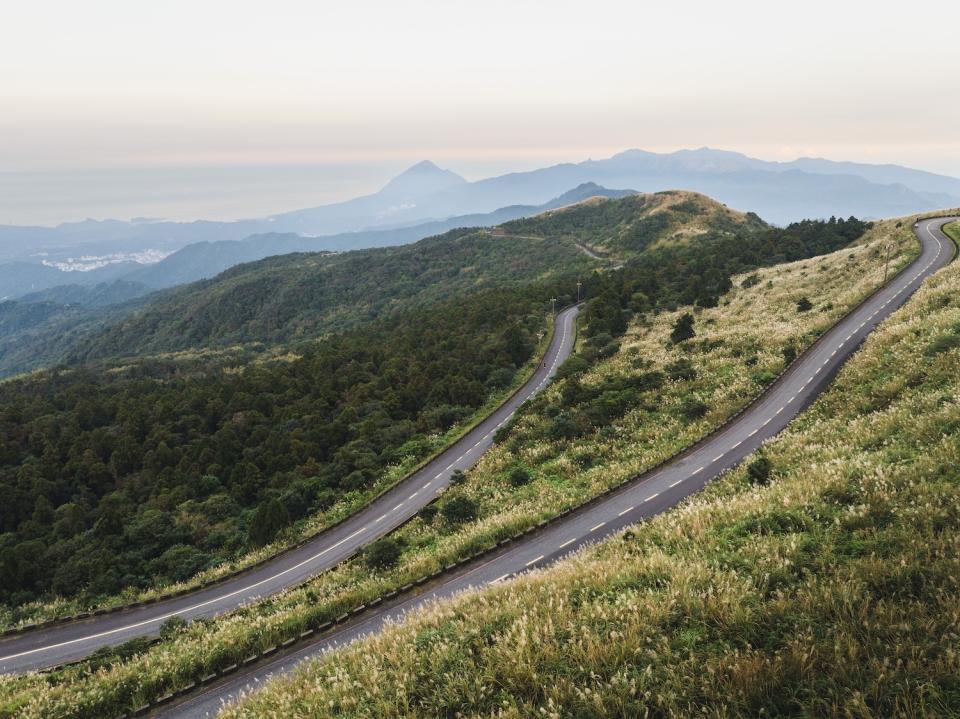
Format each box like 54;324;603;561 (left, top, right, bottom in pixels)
158;218;957;719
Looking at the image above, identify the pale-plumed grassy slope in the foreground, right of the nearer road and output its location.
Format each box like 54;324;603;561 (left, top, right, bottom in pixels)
218;222;960;717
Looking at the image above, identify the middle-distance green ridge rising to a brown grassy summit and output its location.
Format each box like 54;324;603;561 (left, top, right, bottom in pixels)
65;195;763;360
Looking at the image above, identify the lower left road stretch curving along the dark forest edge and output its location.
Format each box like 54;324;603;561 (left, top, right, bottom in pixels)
0;306;579;673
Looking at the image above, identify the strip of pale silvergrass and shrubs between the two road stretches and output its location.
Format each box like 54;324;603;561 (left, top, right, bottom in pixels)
0;217;916;717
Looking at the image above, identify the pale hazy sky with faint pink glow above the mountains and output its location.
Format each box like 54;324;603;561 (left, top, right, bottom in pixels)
0;0;960;222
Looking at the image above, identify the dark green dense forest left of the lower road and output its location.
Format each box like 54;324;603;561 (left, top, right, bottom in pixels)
0;283;572;604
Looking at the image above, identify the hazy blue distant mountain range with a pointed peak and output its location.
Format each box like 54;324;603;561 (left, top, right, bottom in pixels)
0;148;960;299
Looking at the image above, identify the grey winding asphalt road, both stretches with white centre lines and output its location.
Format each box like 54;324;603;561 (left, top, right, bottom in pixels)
0;218;956;717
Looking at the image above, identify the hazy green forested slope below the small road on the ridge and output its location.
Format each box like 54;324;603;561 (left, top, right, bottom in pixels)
70;230;599;361
